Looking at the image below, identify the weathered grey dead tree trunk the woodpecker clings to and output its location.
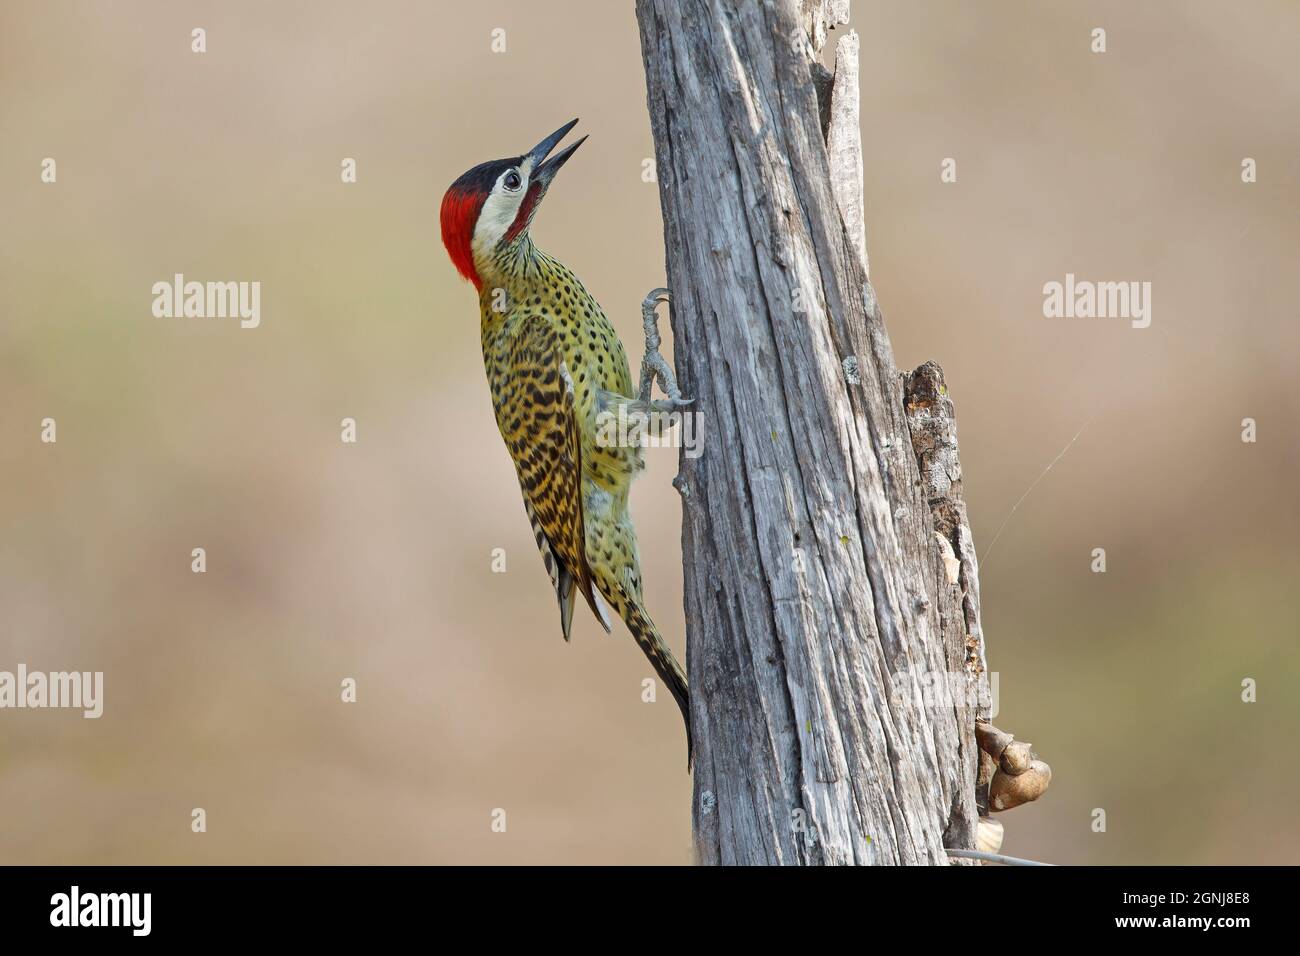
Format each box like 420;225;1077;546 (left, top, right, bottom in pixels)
637;0;983;864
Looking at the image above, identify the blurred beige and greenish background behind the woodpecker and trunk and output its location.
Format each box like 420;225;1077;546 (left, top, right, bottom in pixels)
0;0;1300;864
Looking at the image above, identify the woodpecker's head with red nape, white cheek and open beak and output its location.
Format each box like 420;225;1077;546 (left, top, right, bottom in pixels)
442;120;586;287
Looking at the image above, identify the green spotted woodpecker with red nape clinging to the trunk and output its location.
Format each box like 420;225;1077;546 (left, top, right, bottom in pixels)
441;120;690;763
